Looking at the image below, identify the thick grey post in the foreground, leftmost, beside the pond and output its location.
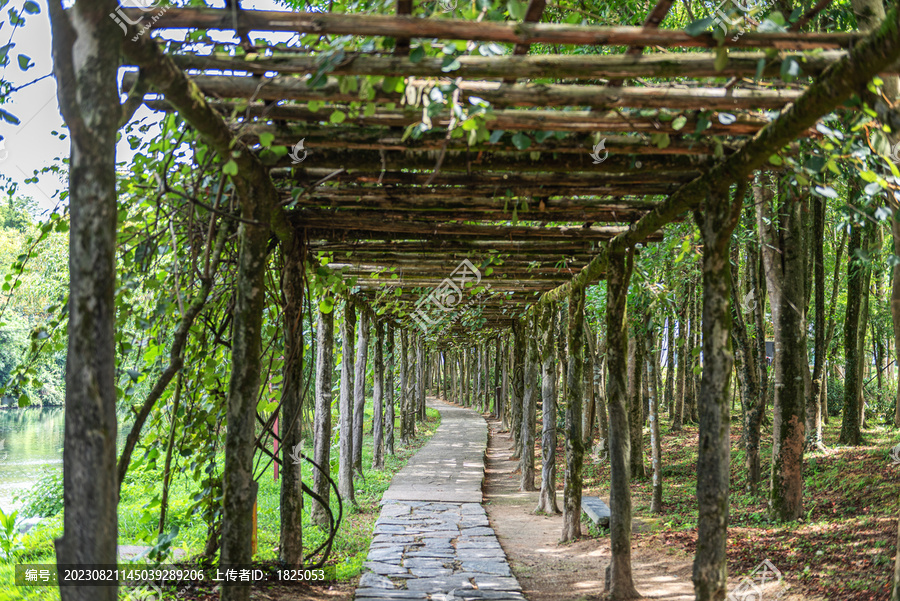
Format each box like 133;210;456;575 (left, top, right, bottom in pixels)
49;0;121;601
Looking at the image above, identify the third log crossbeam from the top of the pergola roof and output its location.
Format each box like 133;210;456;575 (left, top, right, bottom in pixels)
122;71;800;111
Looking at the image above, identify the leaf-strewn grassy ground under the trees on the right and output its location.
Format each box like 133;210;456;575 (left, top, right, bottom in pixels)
557;409;900;601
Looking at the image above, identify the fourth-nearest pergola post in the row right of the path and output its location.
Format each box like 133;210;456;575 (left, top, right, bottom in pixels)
535;302;559;515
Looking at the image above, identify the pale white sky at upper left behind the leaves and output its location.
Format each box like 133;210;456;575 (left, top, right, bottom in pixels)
0;0;285;211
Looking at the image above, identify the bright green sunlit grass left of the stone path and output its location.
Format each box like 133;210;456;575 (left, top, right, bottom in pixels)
0;403;440;601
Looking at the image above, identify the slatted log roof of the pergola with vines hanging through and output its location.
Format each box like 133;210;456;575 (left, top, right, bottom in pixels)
124;0;900;336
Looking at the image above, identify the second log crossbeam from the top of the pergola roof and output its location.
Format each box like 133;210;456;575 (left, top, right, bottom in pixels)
172;50;880;80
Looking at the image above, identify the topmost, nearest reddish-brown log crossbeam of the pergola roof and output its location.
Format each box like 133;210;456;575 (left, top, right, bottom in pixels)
123;8;859;50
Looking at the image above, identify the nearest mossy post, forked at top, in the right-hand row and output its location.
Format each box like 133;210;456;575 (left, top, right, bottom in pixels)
693;186;740;601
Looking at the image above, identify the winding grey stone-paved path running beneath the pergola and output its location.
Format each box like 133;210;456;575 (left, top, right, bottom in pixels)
356;399;525;601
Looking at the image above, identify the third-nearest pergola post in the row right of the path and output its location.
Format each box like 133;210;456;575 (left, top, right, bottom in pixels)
560;286;584;542
